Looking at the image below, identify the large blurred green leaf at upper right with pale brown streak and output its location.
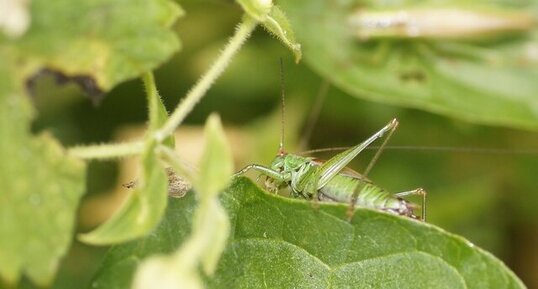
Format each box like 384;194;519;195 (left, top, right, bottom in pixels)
280;0;538;130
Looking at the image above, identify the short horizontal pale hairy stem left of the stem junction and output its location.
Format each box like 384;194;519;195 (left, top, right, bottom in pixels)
67;141;144;160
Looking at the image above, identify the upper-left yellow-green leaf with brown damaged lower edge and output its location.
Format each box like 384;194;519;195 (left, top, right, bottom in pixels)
0;0;182;91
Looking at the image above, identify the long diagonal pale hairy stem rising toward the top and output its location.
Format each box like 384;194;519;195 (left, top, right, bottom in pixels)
155;15;258;142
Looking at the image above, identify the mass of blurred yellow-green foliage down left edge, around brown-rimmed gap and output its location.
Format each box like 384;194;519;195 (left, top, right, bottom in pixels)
0;0;180;285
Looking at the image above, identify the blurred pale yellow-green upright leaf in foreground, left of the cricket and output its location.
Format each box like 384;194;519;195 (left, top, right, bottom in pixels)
132;115;233;289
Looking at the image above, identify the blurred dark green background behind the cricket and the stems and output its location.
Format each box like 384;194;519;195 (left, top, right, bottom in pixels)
15;0;538;288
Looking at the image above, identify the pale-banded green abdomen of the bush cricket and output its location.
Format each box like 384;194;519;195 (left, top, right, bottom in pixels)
318;175;416;218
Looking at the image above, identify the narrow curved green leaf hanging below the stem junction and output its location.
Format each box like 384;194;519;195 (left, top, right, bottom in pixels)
79;140;168;245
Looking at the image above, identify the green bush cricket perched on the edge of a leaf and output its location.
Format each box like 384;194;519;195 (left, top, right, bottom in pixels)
235;63;426;221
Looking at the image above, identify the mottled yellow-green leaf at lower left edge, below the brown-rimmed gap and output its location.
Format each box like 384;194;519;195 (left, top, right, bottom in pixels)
0;59;85;285
